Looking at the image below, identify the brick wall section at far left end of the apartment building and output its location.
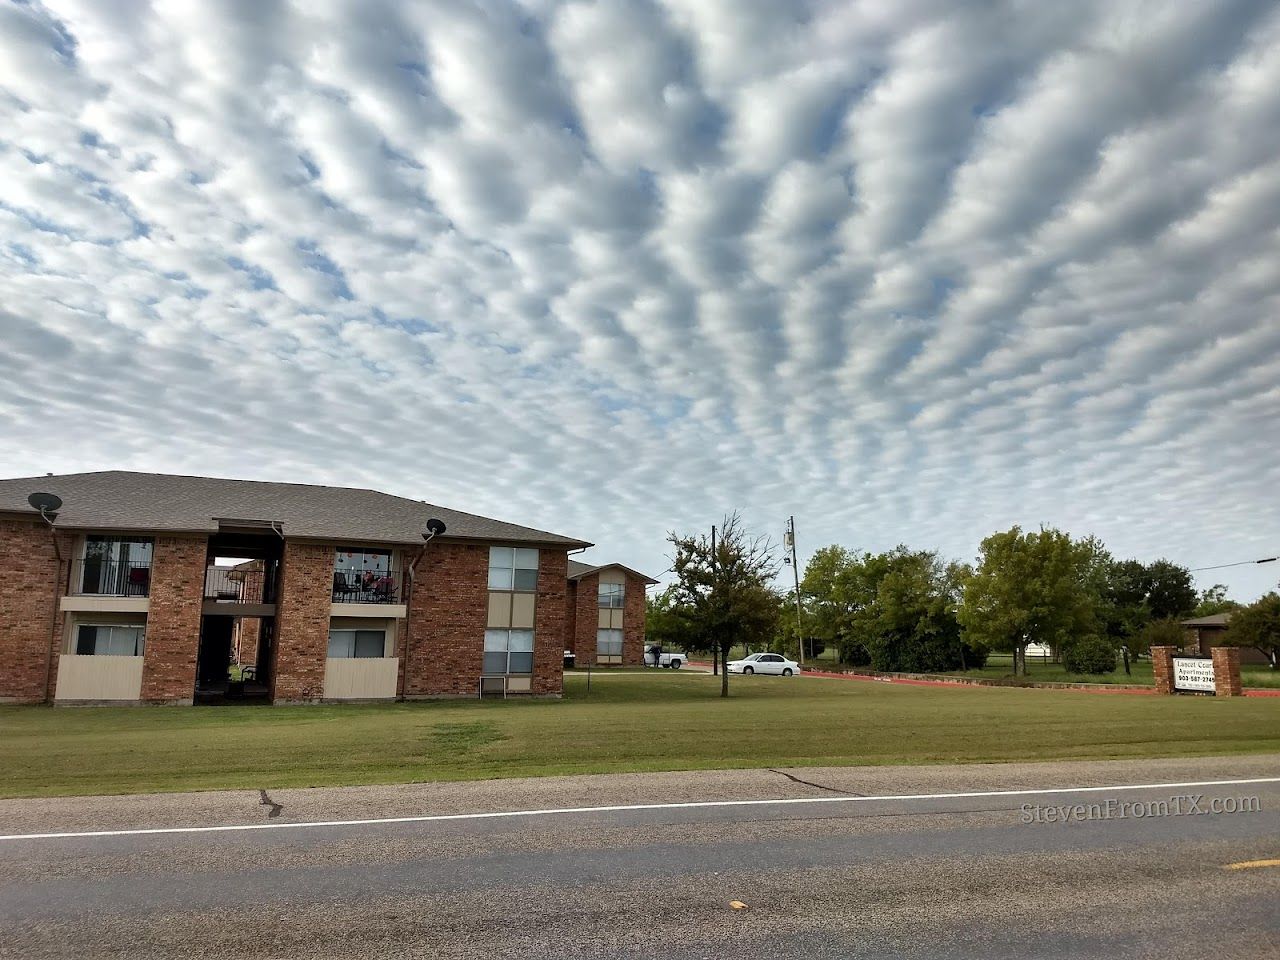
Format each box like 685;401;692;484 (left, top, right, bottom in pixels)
0;517;70;703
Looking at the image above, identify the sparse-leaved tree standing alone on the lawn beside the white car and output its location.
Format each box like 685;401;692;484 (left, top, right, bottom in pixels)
667;513;778;696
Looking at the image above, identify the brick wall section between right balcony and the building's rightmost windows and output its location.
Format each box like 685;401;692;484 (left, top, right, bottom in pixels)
402;541;488;696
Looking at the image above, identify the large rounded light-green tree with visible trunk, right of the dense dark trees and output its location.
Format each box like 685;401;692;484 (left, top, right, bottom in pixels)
957;526;1097;675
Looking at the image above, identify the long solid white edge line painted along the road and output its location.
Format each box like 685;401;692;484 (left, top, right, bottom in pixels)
0;777;1280;841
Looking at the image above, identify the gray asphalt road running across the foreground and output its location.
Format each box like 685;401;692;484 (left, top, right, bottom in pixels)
0;756;1280;960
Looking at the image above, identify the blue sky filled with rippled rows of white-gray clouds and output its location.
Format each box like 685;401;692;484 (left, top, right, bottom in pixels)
0;0;1280;599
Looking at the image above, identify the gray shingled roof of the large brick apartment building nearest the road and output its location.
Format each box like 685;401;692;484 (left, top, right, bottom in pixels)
0;470;591;549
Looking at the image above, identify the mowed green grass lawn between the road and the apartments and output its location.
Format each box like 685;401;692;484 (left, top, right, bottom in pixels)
0;672;1280;797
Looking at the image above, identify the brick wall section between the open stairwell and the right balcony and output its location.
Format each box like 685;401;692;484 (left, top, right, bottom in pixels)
271;540;335;703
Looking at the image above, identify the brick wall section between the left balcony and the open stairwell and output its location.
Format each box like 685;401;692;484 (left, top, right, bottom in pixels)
142;536;209;703
